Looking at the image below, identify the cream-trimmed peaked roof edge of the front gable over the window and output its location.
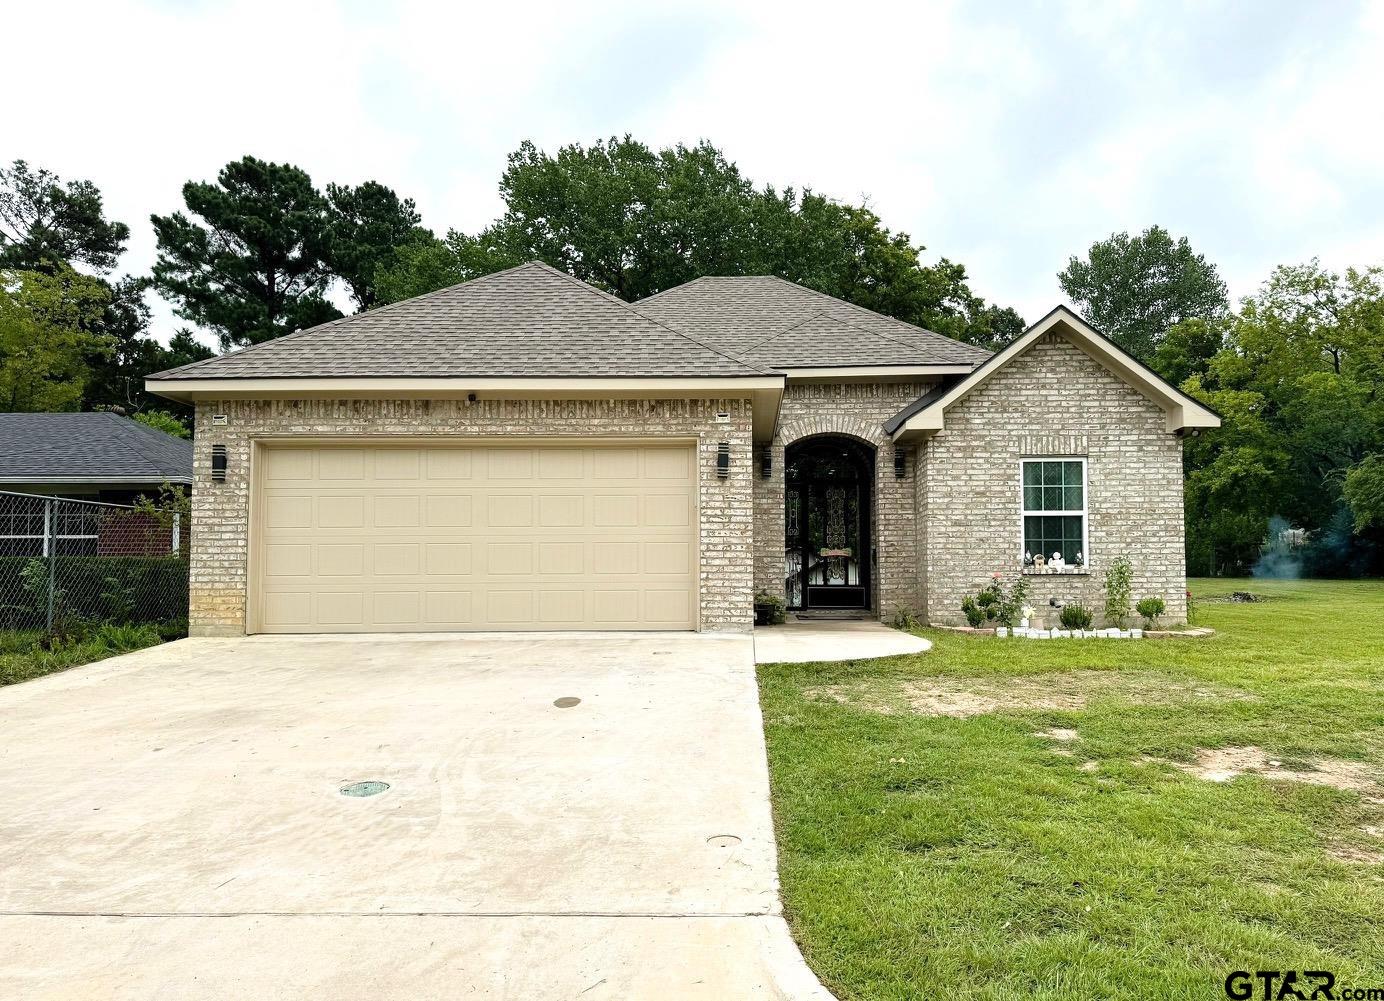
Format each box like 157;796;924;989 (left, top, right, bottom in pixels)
884;306;1221;440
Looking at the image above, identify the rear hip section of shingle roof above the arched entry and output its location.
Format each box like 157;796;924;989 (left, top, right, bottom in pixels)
635;276;990;368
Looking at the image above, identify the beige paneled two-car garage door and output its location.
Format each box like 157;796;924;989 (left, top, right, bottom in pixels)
256;444;696;633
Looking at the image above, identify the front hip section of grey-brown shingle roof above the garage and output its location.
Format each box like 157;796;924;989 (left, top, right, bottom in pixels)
149;262;765;379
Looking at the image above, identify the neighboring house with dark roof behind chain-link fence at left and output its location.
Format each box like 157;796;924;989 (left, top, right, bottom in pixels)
0;413;192;557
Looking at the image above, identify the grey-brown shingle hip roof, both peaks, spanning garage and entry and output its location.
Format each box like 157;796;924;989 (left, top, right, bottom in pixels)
149;262;990;379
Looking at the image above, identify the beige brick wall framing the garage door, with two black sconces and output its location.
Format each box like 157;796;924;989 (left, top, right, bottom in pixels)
190;400;752;635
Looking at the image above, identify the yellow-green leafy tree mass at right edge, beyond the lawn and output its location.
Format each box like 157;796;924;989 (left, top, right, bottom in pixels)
1179;262;1384;573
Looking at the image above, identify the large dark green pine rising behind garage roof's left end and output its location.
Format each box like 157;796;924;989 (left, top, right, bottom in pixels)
151;156;340;349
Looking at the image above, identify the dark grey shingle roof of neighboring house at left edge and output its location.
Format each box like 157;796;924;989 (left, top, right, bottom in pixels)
0;413;192;483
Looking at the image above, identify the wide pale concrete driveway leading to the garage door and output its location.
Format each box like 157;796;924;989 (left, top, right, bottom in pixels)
0;634;829;1001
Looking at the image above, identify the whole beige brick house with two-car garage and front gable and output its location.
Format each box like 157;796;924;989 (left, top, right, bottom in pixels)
148;263;1219;635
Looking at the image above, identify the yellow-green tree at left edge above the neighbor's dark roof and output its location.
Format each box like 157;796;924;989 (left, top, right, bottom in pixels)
0;264;109;411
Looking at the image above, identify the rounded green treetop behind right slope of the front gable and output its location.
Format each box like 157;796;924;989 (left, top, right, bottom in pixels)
1057;226;1229;361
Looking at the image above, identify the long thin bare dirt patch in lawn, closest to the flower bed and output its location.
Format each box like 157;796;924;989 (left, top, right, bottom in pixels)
804;670;1257;719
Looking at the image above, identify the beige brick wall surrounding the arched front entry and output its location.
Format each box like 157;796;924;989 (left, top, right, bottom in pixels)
754;382;931;620
